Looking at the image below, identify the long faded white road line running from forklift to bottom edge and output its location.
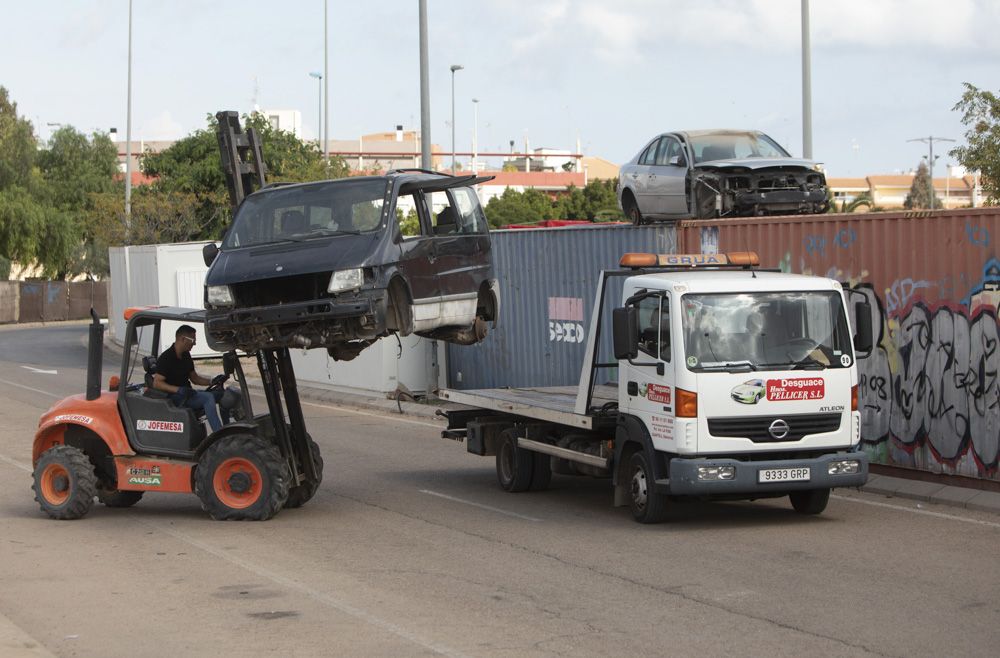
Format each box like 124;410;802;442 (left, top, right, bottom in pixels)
129;514;465;656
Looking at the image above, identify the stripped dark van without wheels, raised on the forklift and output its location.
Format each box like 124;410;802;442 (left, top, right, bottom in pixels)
205;171;500;360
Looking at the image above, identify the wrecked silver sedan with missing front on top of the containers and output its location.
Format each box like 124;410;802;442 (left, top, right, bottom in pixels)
617;130;829;225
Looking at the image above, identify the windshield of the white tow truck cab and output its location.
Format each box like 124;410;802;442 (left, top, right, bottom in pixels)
681;291;854;372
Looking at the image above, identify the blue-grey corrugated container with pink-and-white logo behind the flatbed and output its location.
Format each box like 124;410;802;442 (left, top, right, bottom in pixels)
448;225;676;389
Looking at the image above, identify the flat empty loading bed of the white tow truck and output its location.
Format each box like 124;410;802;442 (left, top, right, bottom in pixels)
439;386;618;430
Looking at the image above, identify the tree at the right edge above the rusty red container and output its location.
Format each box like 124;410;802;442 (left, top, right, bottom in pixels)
949;82;1000;205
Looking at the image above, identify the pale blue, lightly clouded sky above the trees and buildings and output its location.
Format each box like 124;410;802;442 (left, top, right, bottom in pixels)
0;0;1000;177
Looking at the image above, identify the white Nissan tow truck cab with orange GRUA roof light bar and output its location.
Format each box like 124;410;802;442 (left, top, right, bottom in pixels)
613;253;871;502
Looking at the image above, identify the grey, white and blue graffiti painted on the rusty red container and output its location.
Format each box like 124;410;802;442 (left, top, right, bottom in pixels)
779;245;1000;479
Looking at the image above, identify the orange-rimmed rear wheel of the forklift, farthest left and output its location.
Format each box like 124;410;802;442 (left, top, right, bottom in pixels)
31;445;97;520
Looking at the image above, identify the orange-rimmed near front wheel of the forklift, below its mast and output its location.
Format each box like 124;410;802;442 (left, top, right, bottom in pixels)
194;434;291;521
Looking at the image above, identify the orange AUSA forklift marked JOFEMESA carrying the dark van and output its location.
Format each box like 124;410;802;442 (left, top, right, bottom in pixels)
32;307;323;521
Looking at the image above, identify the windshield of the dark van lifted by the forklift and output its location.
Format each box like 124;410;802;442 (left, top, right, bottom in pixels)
222;180;388;249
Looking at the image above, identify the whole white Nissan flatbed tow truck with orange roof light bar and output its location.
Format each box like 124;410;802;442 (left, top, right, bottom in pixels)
441;252;872;523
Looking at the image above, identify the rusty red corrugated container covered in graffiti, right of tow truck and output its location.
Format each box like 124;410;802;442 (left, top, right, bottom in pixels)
678;208;1000;480
